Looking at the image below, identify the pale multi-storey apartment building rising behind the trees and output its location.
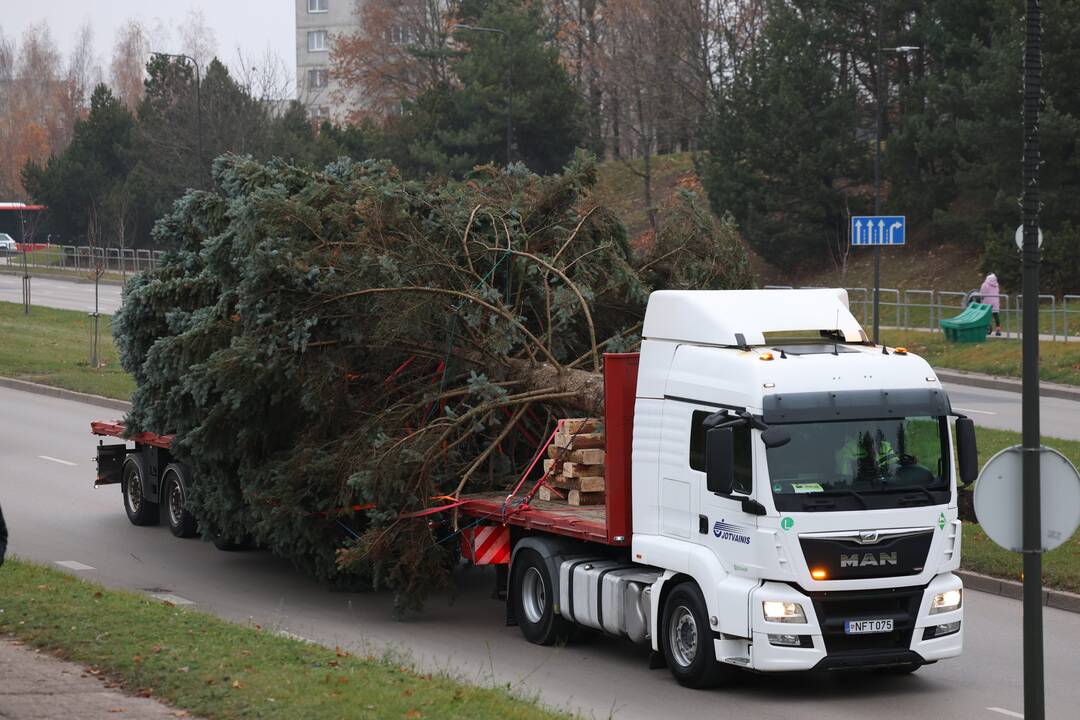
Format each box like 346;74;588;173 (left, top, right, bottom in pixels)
296;0;360;121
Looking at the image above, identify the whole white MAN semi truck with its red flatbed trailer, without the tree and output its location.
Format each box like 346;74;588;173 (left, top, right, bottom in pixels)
94;289;977;687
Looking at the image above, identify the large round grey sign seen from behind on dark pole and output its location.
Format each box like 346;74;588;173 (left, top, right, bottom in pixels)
975;445;1080;553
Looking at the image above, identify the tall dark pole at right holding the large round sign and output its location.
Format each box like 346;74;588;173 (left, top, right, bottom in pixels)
1021;0;1045;720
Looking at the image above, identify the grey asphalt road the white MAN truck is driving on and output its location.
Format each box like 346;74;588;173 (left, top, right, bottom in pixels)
0;389;1080;720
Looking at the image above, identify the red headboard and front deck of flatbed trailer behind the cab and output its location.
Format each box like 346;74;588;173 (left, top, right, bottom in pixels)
461;353;638;545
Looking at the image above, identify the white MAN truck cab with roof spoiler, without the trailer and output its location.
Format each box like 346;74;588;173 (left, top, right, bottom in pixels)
632;289;973;682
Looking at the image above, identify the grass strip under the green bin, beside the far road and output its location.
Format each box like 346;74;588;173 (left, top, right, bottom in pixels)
881;330;1080;385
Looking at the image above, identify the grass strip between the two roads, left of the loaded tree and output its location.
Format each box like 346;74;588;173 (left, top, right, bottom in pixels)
0;302;135;400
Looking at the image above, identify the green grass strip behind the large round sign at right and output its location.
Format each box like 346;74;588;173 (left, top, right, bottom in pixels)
960;427;1080;593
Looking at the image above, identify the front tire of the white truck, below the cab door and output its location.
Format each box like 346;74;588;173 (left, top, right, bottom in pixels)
660;582;733;688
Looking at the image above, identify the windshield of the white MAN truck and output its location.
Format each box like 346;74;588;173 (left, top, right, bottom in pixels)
767;417;949;510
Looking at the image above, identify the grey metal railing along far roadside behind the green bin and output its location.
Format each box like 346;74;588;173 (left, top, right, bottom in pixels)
765;285;1080;342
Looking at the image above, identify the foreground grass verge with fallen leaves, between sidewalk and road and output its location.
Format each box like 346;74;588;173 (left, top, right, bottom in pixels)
0;560;568;720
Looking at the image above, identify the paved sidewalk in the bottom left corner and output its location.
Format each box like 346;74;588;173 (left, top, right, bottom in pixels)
0;638;191;720
